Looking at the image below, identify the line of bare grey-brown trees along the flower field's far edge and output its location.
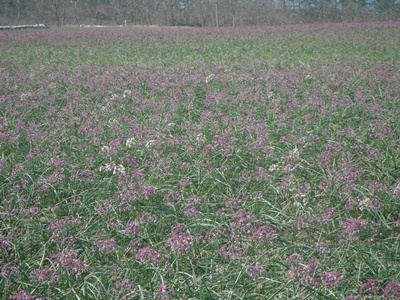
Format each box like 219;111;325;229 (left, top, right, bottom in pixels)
0;0;400;27
